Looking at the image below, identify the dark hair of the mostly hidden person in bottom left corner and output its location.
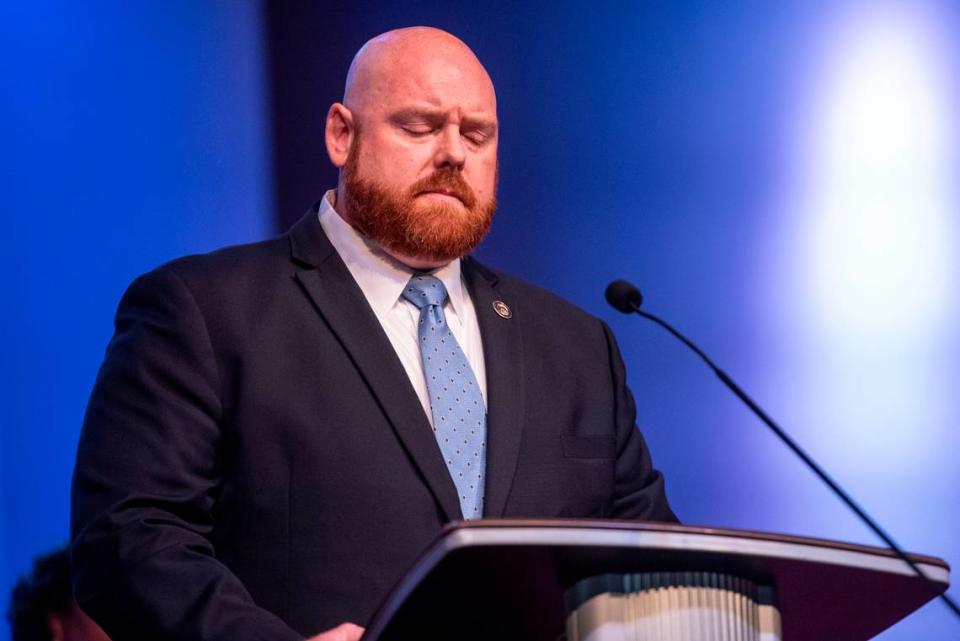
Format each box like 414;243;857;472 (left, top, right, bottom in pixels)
7;546;73;641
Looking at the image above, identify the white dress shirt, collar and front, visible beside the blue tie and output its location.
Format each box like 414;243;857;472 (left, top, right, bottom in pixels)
319;189;487;426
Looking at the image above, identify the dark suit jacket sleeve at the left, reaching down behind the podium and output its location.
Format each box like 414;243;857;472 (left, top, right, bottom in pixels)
71;267;302;641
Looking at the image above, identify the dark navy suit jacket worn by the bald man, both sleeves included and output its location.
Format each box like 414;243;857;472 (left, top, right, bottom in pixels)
71;211;675;641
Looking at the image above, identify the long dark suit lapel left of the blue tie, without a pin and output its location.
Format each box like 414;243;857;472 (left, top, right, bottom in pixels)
290;209;462;520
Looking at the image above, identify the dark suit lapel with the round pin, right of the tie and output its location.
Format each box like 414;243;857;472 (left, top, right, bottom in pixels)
461;258;524;518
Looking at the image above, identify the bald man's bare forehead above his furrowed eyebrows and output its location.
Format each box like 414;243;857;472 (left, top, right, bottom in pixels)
372;55;497;118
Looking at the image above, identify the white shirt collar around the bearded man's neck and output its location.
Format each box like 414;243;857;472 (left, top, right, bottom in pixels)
318;189;466;318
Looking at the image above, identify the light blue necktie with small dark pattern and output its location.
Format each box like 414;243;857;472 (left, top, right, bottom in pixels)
403;274;487;519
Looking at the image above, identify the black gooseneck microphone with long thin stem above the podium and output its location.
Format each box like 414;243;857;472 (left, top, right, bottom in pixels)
605;280;960;618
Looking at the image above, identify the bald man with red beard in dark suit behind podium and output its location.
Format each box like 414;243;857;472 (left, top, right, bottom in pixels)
72;28;675;641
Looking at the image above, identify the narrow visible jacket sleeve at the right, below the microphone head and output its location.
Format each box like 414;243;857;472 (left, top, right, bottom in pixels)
603;323;679;522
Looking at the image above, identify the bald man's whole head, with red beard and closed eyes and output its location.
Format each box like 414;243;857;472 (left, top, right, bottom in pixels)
326;27;499;269
